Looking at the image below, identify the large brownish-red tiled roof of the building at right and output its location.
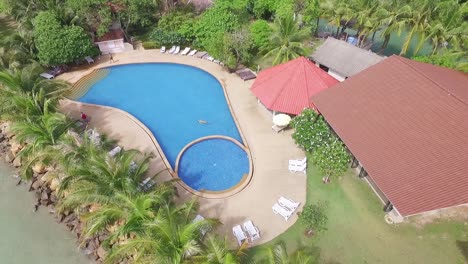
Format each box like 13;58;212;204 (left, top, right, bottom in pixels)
312;56;468;216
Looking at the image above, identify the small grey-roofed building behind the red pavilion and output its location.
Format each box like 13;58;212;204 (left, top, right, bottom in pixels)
310;37;385;82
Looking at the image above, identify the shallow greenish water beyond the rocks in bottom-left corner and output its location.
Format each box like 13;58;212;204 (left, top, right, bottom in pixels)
0;162;92;264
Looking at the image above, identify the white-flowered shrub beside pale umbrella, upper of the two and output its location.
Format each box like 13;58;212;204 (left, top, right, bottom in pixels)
291;109;333;152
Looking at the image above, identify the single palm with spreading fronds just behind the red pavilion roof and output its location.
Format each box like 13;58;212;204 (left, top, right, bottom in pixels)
265;16;309;65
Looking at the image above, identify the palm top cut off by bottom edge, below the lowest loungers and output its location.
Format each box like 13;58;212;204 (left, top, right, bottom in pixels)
254;243;315;264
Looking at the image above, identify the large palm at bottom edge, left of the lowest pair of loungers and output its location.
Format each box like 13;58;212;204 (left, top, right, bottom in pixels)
106;200;219;264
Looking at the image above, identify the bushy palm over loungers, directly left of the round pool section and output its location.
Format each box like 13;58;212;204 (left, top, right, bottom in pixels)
59;150;167;210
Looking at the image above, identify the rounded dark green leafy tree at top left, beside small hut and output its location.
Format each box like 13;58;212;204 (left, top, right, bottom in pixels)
34;12;93;65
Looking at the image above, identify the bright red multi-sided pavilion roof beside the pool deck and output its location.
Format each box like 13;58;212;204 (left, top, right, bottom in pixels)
251;57;338;115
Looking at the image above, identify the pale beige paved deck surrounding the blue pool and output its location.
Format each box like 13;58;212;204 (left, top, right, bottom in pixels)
59;50;306;246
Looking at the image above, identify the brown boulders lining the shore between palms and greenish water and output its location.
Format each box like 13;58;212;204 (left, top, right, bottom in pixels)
0;123;109;263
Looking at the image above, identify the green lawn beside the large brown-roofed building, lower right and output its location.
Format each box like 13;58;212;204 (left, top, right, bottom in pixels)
249;159;468;263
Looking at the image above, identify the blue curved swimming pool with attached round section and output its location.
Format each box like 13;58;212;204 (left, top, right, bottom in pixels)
79;63;250;192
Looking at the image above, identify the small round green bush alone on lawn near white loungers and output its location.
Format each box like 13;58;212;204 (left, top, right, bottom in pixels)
299;201;328;232
